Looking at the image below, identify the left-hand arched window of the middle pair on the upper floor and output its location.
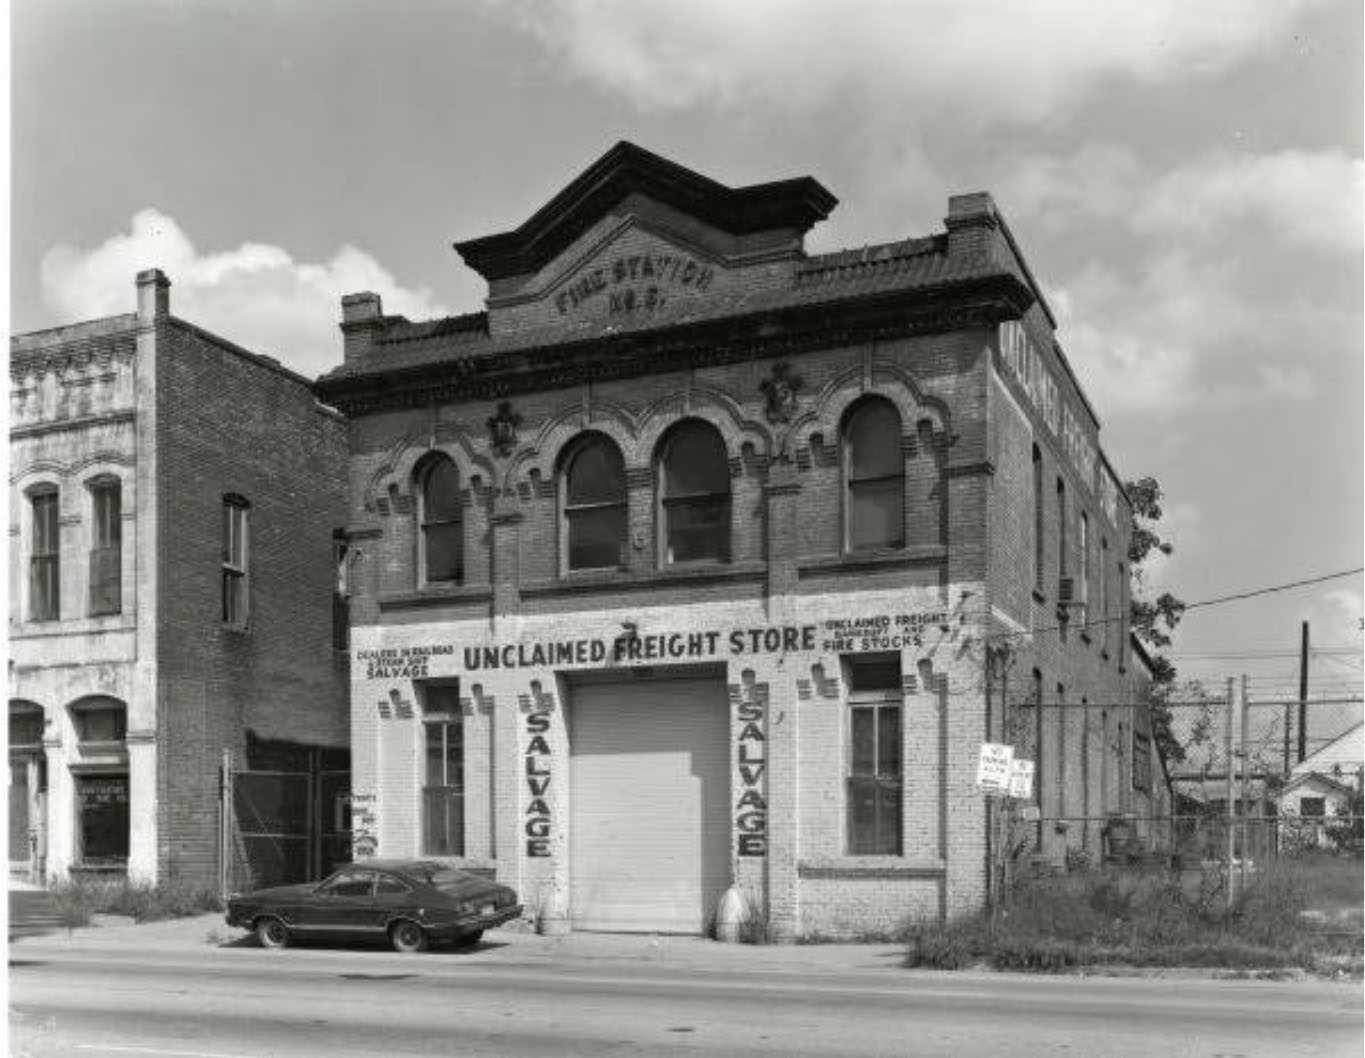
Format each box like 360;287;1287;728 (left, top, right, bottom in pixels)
560;434;625;569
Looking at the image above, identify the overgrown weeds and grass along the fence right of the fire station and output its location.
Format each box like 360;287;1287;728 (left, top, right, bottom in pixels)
906;856;1362;976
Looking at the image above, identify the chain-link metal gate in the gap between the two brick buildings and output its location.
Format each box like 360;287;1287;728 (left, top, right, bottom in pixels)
220;747;351;891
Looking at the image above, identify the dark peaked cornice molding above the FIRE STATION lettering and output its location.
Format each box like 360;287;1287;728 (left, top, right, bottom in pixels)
455;141;837;285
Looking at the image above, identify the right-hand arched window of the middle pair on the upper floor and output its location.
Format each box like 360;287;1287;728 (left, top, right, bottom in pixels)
659;419;730;565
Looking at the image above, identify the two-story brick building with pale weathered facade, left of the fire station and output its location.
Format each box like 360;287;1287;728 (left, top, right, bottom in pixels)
10;270;349;881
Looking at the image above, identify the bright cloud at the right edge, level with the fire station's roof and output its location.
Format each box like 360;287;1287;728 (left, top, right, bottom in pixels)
1133;150;1365;253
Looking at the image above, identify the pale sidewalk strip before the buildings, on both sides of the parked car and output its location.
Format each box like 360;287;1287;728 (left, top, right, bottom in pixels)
10;913;905;973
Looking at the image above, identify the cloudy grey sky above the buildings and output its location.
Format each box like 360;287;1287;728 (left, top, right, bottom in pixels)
10;0;1365;698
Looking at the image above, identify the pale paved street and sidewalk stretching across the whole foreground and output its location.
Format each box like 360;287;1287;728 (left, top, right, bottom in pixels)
10;927;1362;1058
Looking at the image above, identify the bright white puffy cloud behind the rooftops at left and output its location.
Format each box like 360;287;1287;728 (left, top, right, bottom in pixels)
41;209;448;377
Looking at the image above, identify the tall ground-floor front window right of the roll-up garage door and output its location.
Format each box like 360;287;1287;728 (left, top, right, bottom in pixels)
846;654;902;856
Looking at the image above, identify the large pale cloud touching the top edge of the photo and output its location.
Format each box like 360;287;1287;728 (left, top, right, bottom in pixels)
494;0;1310;124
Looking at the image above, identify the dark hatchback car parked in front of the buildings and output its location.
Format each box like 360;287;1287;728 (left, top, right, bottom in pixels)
227;860;523;953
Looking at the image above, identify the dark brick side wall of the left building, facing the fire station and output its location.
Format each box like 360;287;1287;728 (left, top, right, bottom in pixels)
157;319;349;879
